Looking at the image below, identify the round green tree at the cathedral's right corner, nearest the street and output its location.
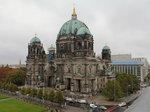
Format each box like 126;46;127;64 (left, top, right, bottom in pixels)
102;80;123;100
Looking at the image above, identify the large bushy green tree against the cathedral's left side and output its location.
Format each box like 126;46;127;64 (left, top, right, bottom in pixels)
6;70;25;86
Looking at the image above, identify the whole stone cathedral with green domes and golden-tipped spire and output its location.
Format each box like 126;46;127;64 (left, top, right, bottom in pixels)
26;8;111;93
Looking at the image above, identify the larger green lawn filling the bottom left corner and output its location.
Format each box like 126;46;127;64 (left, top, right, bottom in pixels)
0;99;46;112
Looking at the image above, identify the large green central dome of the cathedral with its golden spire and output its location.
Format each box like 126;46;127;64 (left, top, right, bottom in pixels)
58;8;91;37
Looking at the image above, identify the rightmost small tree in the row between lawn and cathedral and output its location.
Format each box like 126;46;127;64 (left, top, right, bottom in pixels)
54;90;64;104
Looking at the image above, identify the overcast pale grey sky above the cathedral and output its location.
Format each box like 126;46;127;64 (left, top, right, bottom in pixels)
0;0;150;64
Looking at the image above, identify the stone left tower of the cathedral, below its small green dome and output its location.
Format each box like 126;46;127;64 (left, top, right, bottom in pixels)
26;37;46;86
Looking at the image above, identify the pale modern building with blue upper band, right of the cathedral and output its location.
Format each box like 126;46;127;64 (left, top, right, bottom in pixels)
111;54;149;81
